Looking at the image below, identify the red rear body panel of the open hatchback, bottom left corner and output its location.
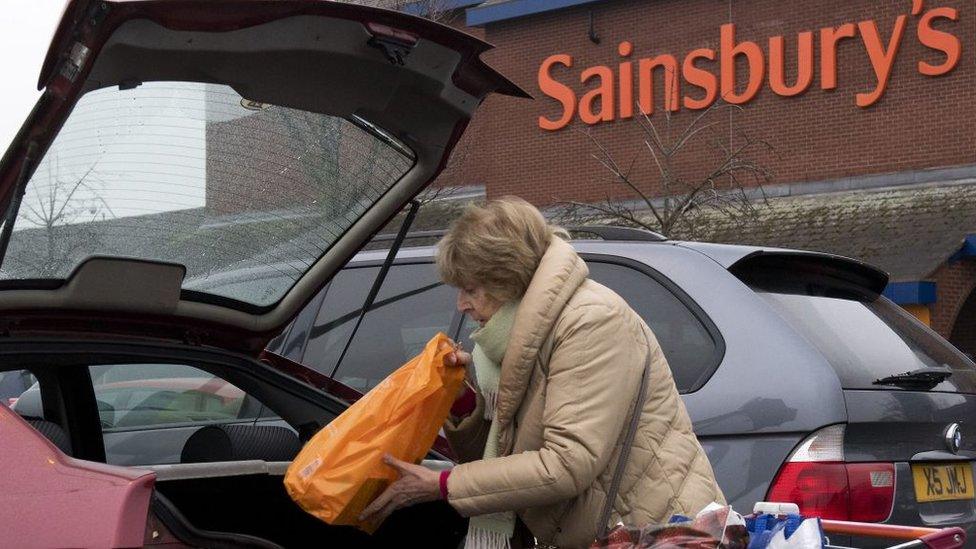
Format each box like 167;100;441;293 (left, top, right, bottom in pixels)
0;406;156;549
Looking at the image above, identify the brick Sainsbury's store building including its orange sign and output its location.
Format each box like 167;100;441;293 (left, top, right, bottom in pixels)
432;0;976;353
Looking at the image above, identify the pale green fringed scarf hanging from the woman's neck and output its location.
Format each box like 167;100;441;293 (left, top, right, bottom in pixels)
464;301;519;549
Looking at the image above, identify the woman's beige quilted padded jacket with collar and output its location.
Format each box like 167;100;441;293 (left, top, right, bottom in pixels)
445;238;724;547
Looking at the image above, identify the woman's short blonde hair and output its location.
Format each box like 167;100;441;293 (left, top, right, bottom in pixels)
437;196;569;303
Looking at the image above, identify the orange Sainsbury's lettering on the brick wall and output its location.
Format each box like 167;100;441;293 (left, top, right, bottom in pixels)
539;0;962;130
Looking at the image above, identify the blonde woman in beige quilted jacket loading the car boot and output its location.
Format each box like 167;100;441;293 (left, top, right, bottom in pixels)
364;198;724;549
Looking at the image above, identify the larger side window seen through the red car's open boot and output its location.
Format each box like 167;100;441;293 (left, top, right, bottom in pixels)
90;364;276;465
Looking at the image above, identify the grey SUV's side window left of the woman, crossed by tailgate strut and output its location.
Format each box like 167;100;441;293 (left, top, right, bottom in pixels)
303;263;456;392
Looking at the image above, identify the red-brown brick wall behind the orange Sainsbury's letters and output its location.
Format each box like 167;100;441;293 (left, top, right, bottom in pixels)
442;0;976;204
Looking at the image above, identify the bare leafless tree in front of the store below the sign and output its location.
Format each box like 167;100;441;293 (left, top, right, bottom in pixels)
553;103;772;237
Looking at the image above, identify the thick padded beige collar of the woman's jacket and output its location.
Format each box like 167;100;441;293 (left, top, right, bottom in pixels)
495;237;589;432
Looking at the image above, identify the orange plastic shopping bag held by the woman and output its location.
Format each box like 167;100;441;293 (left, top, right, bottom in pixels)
285;334;464;532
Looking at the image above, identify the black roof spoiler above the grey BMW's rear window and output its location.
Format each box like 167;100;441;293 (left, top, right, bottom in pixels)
729;250;888;301
